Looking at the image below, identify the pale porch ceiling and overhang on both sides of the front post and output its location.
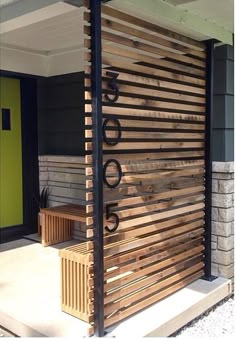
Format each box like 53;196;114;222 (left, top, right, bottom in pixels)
0;0;233;76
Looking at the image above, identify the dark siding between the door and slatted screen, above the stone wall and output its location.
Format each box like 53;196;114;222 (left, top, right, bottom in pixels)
38;73;85;156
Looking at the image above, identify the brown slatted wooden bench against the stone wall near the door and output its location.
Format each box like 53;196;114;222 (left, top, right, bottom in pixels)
40;204;86;247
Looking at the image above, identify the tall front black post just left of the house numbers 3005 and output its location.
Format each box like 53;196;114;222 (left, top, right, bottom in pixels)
90;0;104;337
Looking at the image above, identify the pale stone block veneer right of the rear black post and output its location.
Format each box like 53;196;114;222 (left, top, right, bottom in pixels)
212;162;234;281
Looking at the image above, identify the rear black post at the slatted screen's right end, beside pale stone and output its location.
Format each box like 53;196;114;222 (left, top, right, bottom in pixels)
204;40;215;281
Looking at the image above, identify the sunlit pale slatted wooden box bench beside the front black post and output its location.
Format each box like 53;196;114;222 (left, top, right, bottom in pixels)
59;242;94;323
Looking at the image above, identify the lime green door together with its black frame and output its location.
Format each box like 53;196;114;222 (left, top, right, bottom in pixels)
0;75;38;243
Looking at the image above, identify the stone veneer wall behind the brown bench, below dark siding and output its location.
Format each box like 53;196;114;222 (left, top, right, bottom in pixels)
39;155;86;240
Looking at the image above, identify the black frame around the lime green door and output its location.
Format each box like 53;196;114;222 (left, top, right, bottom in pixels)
0;70;39;243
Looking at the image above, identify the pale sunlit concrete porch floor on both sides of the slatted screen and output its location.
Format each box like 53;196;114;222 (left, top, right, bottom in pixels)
0;234;232;338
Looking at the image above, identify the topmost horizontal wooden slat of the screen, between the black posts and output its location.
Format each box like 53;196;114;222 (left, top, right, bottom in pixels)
102;5;205;50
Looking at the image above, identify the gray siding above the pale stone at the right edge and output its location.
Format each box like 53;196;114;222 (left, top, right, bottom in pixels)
213;45;234;161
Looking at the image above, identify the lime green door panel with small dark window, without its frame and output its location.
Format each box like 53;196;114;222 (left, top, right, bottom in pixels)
0;77;23;228
